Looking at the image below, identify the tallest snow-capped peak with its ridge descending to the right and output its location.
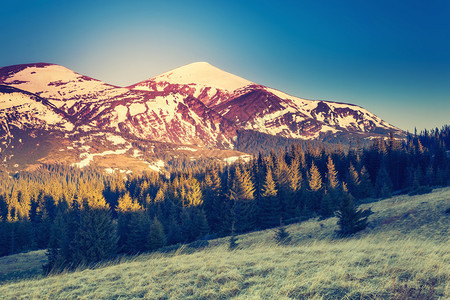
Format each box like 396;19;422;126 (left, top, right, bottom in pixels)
129;62;401;139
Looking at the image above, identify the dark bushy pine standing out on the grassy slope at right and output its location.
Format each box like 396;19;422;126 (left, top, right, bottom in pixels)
336;193;368;236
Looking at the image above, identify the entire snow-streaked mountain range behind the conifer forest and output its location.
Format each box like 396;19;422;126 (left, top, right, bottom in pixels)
0;62;404;170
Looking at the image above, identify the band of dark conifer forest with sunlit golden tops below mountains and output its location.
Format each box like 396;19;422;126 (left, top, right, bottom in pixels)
0;126;450;272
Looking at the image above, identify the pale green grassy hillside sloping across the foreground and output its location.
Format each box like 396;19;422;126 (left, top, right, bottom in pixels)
0;188;450;299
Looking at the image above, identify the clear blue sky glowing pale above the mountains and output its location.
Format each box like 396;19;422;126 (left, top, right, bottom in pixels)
0;0;450;131
